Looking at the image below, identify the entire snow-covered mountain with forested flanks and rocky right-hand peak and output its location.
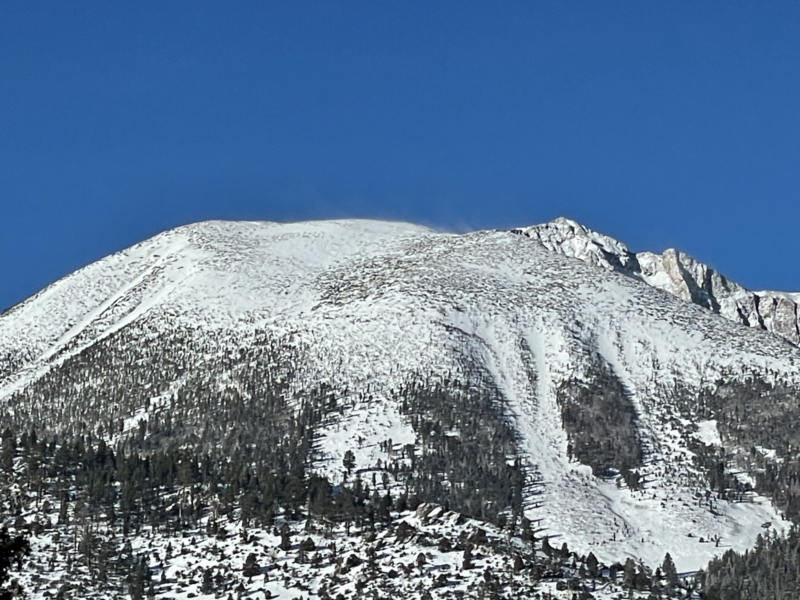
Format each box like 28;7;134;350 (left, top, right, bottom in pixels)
0;219;800;597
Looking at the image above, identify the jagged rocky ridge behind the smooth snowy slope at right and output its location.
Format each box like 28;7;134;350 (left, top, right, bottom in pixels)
512;217;800;346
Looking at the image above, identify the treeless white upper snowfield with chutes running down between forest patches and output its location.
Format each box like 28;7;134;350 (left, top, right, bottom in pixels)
0;221;800;570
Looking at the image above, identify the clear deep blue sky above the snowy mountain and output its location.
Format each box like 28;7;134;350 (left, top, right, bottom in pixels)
0;0;800;307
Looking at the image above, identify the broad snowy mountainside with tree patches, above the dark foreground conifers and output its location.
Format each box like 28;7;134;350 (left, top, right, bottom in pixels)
0;221;800;570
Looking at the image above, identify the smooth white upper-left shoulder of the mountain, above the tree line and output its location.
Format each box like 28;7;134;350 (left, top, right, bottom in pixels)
0;222;432;392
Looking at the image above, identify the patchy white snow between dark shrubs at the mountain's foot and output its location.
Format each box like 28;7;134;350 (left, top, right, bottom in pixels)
7;488;680;600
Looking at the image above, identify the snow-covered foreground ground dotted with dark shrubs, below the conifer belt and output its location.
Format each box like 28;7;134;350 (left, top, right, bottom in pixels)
3;468;690;600
